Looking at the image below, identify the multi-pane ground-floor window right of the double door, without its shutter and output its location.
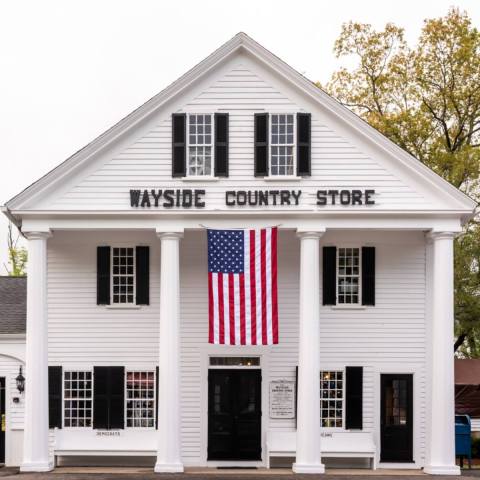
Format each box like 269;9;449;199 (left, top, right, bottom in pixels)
320;371;343;428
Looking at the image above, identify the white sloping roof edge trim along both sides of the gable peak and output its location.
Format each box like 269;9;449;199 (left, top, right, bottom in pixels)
2;32;476;214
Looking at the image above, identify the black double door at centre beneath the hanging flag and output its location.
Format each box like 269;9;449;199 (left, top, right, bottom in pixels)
208;369;262;460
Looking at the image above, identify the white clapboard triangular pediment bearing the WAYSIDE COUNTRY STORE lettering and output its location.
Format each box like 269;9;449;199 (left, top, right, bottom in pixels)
7;34;474;216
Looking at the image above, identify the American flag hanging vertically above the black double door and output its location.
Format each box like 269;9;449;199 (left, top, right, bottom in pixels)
207;227;278;345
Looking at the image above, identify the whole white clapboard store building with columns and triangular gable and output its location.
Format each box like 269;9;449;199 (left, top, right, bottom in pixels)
3;33;475;474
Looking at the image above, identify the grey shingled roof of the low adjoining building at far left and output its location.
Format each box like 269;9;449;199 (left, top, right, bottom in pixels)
0;276;27;335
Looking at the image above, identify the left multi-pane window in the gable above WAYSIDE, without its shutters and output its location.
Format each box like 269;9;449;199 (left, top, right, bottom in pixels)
188;114;213;176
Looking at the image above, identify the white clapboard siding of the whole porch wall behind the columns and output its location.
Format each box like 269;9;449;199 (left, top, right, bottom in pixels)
48;231;425;465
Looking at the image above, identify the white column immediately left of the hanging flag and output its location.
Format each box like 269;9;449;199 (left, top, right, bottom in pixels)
155;233;183;473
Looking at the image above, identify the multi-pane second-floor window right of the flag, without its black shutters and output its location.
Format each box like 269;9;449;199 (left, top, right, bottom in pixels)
337;248;360;304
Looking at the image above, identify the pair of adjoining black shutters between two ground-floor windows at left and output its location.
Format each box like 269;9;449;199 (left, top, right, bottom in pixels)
93;367;125;430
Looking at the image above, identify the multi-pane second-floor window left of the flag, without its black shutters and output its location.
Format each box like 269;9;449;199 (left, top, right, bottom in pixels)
112;247;135;304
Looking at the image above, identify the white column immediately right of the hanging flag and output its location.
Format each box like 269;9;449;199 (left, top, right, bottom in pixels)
293;232;325;473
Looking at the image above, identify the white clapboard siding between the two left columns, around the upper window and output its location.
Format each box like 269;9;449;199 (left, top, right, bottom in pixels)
48;232;160;366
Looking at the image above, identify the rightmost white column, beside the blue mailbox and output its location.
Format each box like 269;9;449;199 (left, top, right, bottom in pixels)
424;232;460;475
